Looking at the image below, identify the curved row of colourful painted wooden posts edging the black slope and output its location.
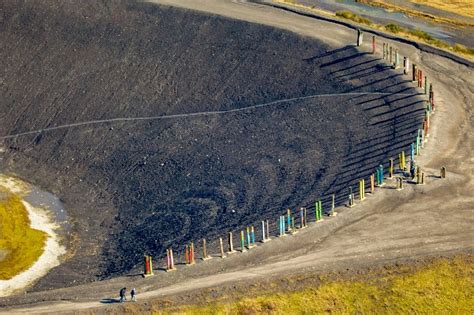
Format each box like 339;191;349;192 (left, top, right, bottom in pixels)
144;30;446;276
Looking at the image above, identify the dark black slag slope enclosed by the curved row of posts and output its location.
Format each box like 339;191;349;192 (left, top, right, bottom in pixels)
0;0;423;289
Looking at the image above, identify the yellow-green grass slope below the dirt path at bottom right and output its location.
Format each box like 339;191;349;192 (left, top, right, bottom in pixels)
155;256;474;314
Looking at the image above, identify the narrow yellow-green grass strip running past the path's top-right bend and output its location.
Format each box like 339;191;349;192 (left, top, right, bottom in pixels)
273;0;474;60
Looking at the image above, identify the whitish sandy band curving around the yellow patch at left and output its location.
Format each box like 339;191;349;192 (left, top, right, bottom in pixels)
0;175;66;297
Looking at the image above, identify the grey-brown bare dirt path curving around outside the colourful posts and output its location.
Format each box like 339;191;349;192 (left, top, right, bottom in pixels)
0;0;474;314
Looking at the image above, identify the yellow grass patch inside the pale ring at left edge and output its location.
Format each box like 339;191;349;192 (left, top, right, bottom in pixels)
0;187;47;280
